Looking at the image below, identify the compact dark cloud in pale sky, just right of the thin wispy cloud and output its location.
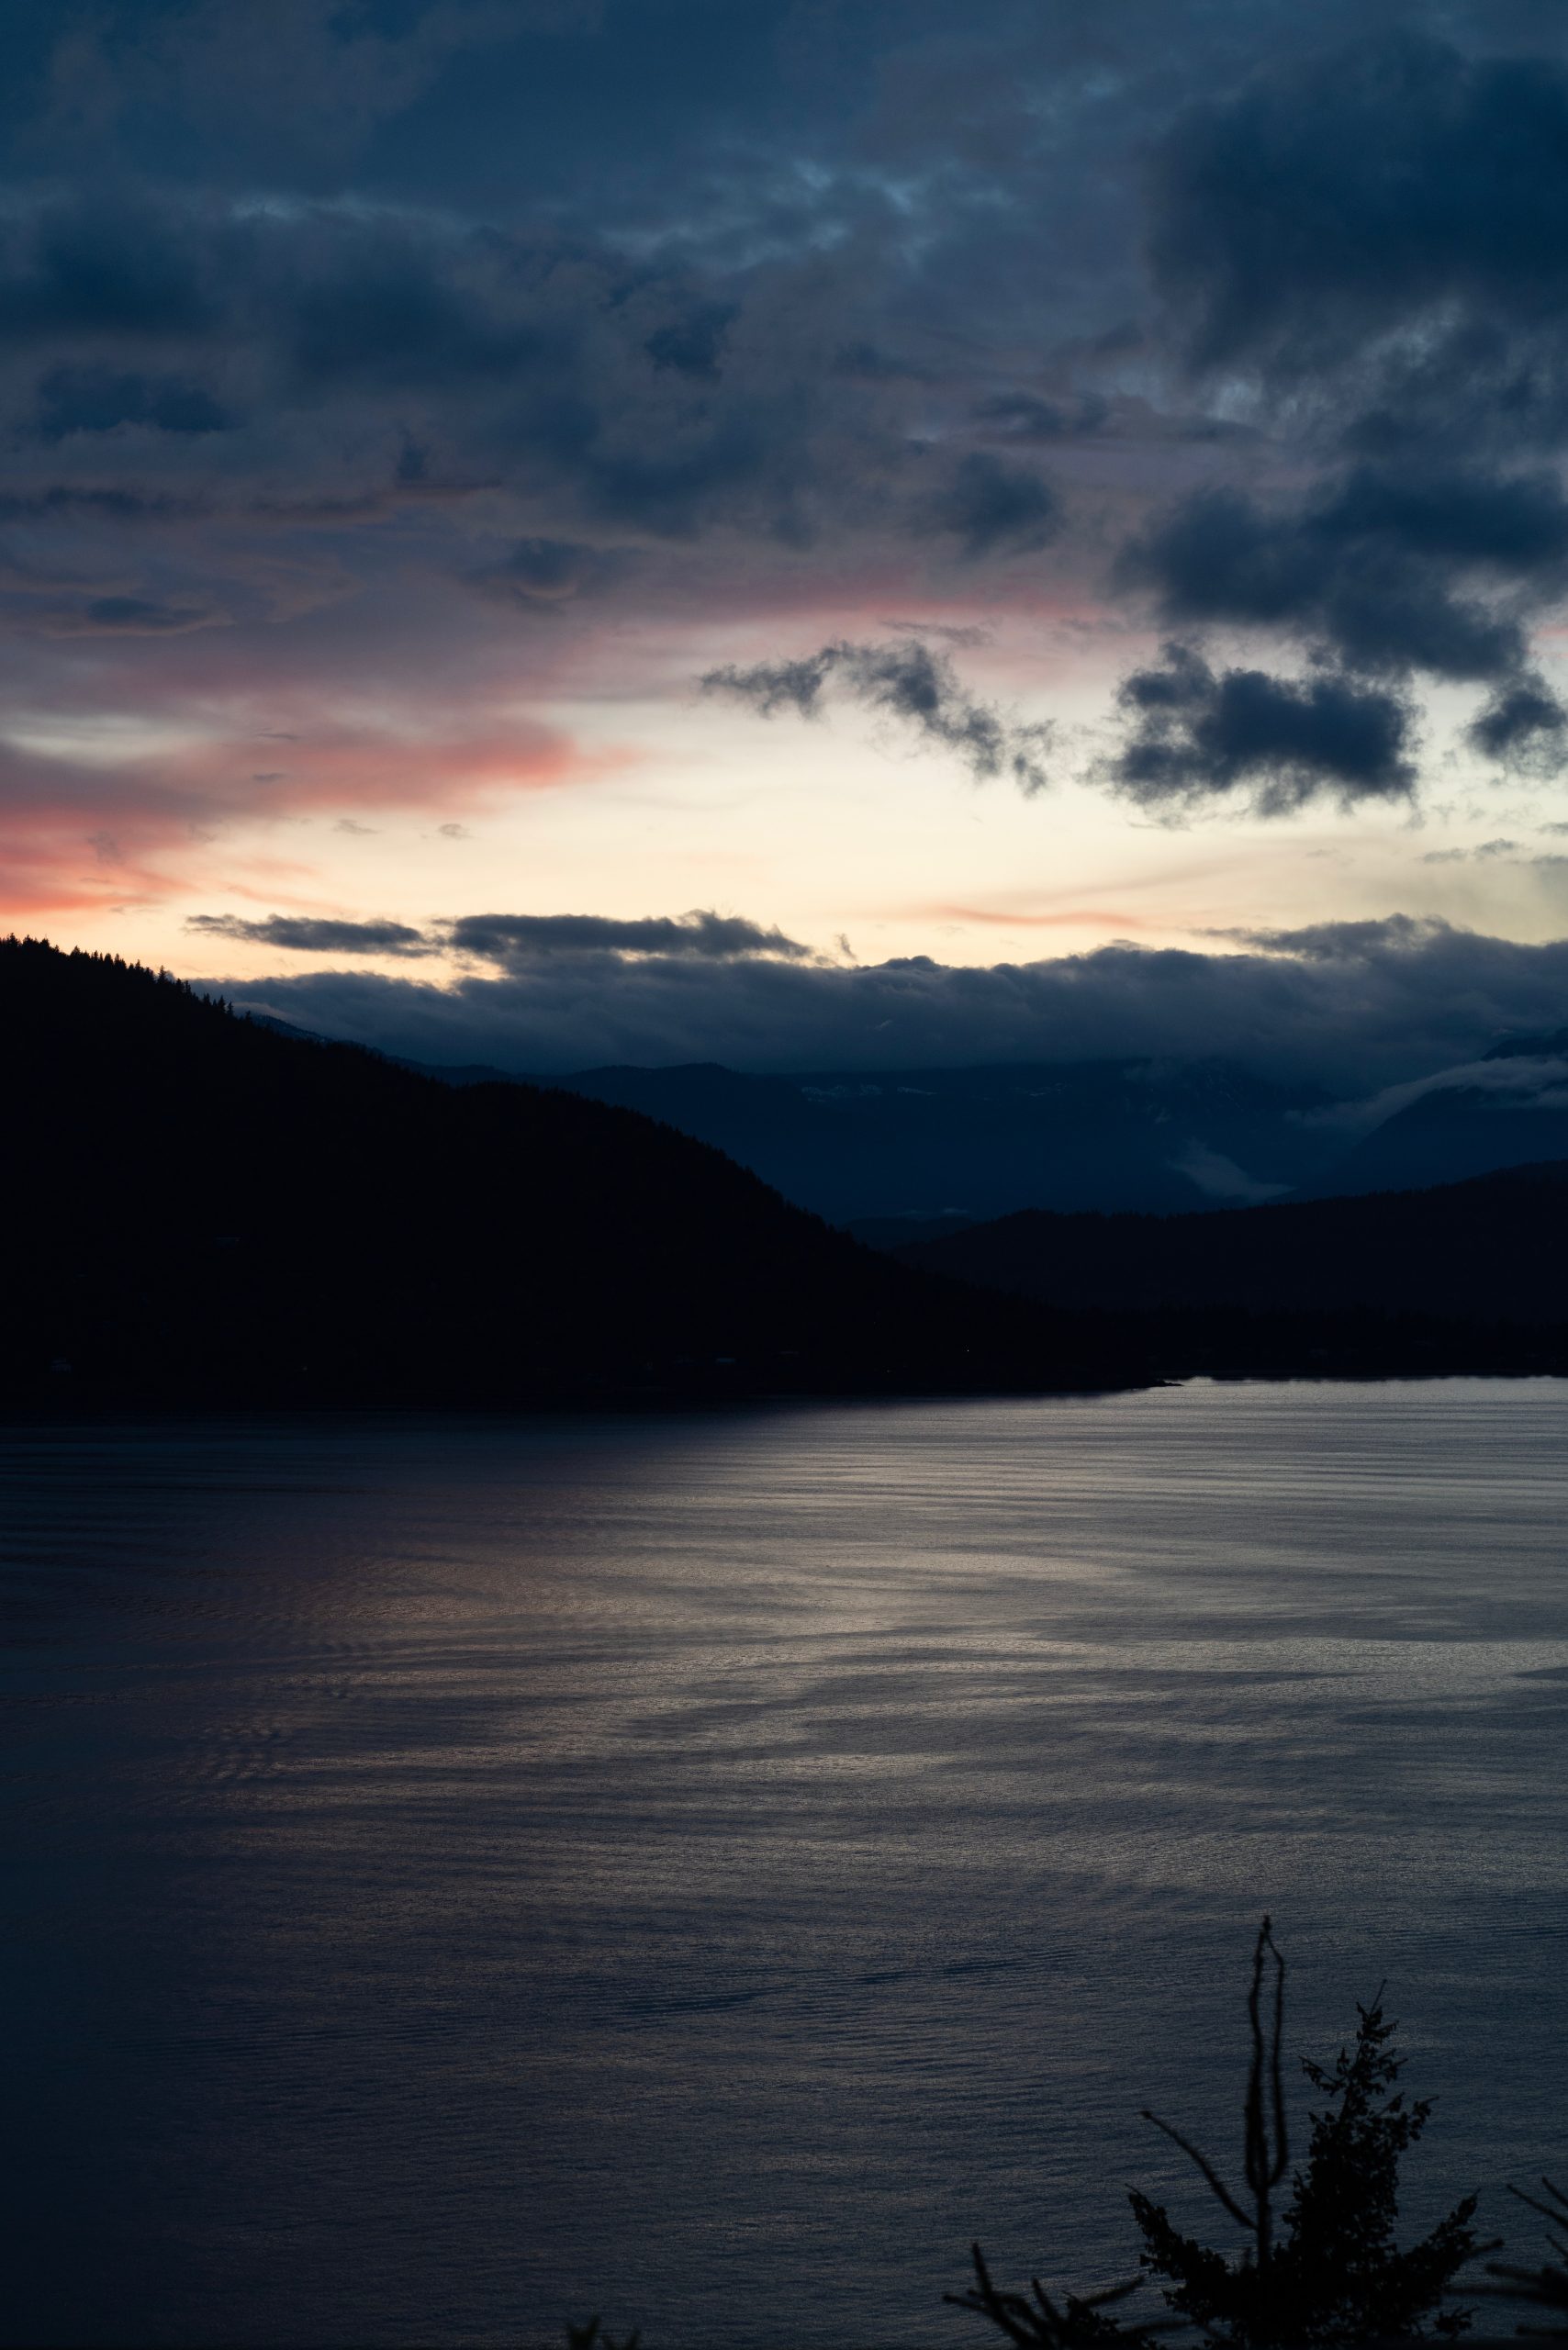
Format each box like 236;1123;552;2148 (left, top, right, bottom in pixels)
1105;643;1416;815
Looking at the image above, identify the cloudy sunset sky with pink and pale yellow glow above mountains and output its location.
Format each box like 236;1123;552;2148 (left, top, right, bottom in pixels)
0;0;1568;1086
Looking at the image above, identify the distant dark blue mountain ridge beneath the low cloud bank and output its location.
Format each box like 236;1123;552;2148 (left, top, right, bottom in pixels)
240;996;1568;1246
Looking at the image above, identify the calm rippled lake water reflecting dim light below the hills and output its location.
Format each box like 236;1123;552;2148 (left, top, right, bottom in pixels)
0;1382;1568;2350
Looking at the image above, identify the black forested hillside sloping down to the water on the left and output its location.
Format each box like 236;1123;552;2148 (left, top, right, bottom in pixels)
0;940;1124;1403
